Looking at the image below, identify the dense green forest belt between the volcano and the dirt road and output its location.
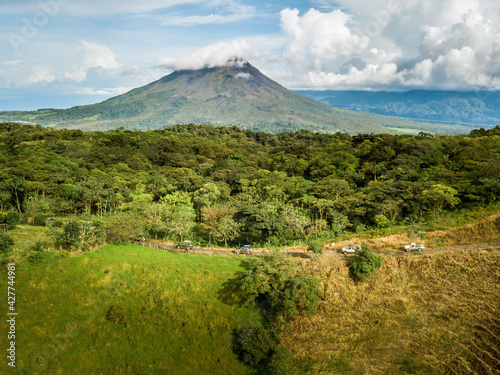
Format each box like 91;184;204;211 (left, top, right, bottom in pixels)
0;123;500;244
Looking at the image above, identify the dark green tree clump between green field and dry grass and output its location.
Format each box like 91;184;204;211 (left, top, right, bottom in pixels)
224;253;320;375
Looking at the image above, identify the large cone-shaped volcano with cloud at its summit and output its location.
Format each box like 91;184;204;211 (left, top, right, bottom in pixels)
0;61;484;134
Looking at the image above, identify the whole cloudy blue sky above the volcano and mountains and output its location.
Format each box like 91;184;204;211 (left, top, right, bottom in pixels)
0;0;500;110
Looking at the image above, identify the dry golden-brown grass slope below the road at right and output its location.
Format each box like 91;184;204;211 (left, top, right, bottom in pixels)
286;249;500;375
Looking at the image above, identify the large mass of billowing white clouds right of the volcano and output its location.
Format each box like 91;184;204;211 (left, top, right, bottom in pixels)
281;0;500;89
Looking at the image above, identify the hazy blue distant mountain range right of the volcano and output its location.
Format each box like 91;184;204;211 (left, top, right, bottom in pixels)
296;90;500;126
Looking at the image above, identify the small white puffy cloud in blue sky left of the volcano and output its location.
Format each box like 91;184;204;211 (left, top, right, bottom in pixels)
64;40;121;82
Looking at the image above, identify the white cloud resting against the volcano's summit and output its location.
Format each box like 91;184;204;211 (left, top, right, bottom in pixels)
160;40;252;70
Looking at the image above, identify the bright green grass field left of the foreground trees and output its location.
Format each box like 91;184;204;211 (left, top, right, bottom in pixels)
0;242;258;374
